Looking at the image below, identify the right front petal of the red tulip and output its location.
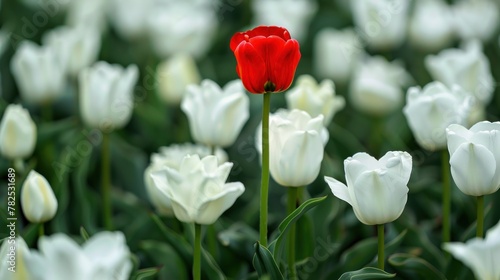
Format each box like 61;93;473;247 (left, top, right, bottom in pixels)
268;39;300;92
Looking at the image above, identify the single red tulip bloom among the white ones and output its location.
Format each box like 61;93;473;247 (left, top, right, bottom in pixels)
230;26;300;93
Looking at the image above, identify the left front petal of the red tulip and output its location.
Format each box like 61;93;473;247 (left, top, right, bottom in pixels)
234;42;267;93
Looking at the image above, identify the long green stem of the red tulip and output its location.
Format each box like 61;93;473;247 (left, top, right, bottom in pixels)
260;92;271;247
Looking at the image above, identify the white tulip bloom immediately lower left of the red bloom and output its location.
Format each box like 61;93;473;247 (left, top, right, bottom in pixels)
181;80;250;147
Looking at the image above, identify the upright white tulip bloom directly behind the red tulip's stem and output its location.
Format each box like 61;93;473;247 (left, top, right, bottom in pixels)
255;109;329;187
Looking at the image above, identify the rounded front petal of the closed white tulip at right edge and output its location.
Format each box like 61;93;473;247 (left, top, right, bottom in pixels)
450;143;498;196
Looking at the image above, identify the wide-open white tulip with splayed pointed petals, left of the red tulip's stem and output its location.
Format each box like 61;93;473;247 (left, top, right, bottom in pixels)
151;155;245;225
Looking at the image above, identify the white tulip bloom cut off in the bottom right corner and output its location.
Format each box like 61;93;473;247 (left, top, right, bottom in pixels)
443;222;500;280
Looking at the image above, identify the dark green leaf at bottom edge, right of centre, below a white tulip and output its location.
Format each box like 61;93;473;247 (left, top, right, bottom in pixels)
388;253;446;279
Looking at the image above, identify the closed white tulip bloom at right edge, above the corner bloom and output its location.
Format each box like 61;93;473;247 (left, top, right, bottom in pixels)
446;121;500;196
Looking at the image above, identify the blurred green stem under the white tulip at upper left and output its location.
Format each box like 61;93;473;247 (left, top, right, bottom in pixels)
101;133;113;230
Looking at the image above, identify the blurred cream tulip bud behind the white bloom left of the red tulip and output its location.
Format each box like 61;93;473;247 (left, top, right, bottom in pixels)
156;53;201;105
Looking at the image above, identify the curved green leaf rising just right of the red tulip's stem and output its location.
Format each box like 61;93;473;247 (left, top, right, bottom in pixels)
269;196;327;260
